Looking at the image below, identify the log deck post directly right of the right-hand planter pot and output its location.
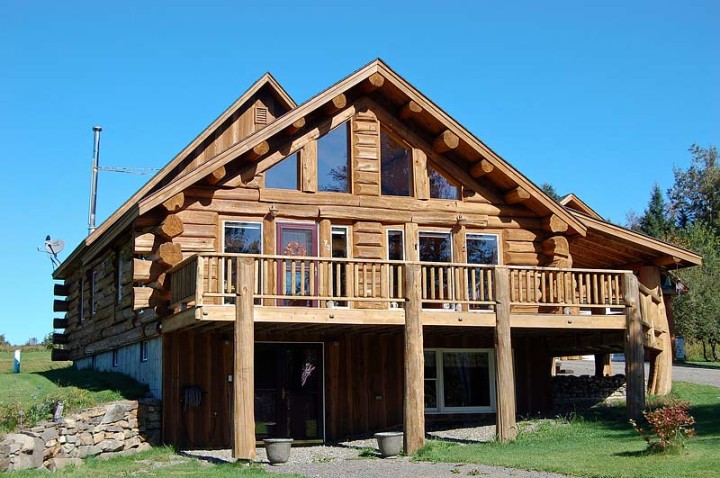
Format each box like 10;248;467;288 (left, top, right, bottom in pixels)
403;264;425;455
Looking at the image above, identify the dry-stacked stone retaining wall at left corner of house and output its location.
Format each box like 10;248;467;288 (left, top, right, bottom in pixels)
0;398;162;470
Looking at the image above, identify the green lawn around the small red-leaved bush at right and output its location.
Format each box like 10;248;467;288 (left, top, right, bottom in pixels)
415;383;720;478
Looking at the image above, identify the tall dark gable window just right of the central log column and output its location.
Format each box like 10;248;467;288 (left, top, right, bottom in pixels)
380;130;413;196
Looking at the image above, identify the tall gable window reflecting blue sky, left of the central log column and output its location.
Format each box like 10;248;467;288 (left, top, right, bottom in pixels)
317;123;350;193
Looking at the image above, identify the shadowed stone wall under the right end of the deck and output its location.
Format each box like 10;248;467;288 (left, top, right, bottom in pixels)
552;375;625;408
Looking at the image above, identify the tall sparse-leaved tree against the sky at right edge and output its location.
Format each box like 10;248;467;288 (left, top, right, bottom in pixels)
668;144;720;232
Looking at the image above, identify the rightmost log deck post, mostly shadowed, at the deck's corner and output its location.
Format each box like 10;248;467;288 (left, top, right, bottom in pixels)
623;273;645;420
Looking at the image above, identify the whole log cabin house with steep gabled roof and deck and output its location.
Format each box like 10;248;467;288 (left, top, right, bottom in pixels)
53;60;700;459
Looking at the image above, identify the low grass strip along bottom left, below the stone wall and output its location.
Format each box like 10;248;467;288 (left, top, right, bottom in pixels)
8;447;299;478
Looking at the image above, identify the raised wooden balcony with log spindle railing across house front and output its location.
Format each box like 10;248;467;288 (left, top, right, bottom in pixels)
169;253;648;332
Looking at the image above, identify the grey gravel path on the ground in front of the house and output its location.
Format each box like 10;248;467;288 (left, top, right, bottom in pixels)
183;421;564;478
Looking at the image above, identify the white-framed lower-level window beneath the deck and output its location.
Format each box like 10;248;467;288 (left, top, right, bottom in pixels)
425;349;495;413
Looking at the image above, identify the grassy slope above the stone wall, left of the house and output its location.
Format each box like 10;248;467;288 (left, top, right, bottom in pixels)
0;351;147;431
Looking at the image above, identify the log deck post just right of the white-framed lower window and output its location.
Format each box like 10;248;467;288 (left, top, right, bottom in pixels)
495;267;517;443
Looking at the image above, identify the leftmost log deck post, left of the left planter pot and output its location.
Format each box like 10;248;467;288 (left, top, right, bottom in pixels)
233;258;255;460
